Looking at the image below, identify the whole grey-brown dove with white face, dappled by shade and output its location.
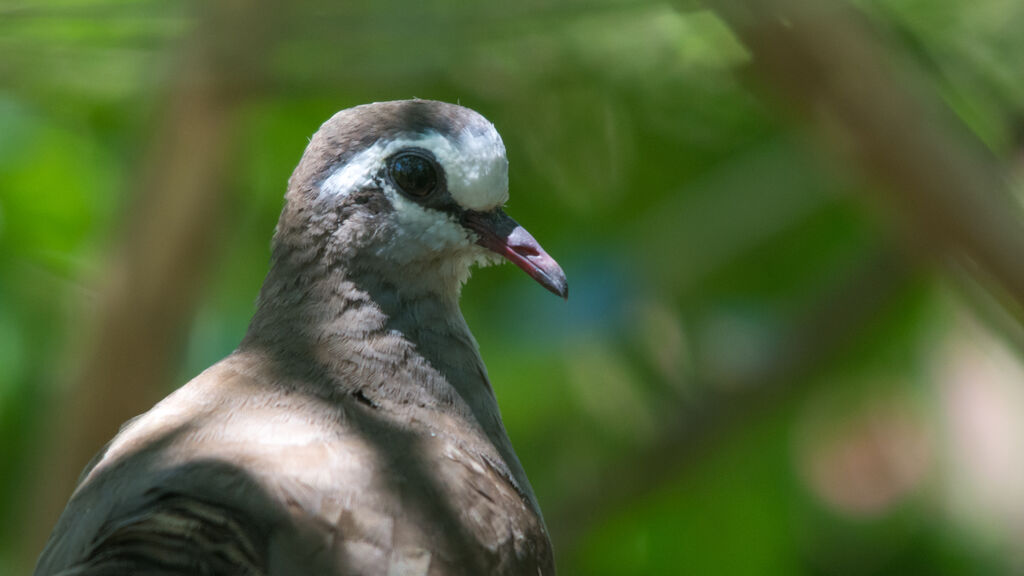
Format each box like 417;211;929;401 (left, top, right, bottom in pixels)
35;99;568;576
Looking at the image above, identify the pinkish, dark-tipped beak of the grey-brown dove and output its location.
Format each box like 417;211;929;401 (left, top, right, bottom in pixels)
462;209;569;298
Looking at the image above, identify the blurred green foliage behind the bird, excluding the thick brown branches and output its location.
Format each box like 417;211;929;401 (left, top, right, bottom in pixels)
0;0;1024;575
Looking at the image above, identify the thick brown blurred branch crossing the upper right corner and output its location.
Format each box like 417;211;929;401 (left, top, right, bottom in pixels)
712;0;1024;320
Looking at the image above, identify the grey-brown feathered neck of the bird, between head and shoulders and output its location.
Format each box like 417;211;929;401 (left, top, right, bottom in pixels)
240;253;500;428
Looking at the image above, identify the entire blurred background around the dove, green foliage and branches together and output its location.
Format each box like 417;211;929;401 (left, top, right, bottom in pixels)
0;0;1024;575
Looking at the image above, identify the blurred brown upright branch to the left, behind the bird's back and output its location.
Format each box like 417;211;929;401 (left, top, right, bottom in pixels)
23;2;286;566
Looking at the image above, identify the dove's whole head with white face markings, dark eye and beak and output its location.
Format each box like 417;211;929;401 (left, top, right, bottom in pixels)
275;99;568;297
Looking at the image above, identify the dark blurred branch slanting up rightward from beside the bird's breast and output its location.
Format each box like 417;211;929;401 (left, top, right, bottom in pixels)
547;247;916;556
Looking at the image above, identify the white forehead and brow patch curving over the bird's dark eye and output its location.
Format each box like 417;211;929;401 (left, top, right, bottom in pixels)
321;129;509;212
